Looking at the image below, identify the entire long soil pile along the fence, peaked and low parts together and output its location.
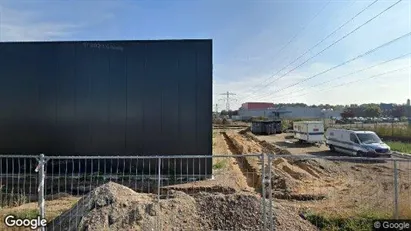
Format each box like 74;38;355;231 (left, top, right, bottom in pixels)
47;182;316;231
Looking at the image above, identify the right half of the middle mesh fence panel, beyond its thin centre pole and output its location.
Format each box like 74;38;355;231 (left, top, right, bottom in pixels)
157;155;268;230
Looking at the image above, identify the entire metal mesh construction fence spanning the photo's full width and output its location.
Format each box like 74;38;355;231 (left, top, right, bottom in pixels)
0;154;411;230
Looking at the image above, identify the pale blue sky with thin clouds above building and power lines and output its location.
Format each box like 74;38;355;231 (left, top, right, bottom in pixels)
0;0;411;108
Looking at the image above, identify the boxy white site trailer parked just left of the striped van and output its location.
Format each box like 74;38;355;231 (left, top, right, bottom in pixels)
293;121;324;143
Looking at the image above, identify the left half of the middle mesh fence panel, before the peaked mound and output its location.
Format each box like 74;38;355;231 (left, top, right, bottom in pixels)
46;156;166;230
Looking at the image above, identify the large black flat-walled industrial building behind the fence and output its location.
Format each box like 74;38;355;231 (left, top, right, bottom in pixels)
0;40;212;175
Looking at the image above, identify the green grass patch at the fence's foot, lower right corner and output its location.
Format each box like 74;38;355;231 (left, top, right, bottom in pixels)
303;212;390;231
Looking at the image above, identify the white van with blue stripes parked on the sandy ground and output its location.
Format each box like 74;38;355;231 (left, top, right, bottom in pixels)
325;128;391;157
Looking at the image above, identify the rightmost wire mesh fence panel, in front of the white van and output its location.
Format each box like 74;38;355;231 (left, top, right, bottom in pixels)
272;155;411;230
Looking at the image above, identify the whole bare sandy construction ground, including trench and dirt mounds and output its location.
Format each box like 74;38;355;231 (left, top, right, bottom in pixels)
0;128;411;230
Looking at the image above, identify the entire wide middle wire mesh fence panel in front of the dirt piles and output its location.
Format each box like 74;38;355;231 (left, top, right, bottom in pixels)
45;154;268;230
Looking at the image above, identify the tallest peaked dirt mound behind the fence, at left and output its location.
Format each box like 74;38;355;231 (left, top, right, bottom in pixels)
48;182;198;231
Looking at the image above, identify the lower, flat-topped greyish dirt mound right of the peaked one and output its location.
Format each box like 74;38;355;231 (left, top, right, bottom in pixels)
196;193;317;231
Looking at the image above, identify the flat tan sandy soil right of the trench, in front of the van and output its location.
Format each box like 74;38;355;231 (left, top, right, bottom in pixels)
248;134;411;218
